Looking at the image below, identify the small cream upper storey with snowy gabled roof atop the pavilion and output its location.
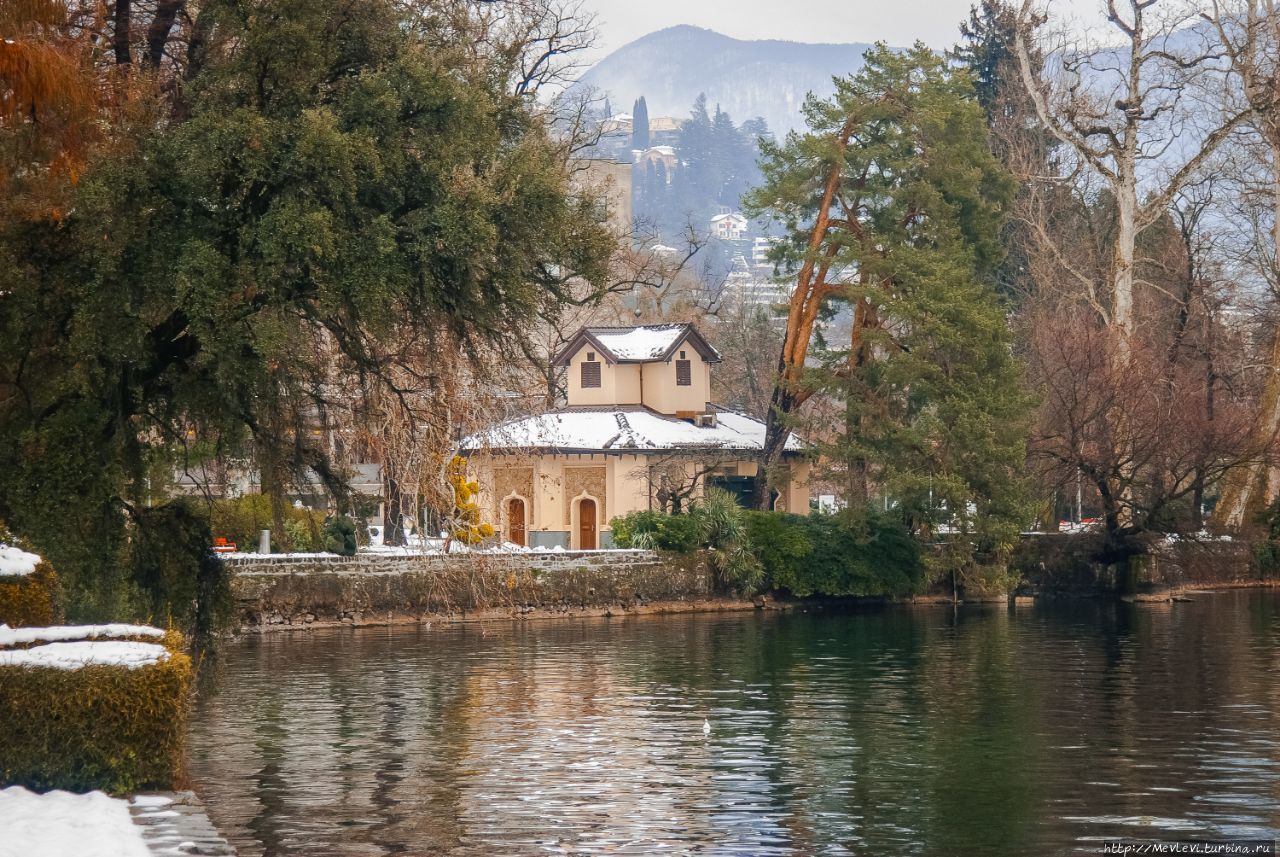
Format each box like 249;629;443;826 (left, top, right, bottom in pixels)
552;324;721;416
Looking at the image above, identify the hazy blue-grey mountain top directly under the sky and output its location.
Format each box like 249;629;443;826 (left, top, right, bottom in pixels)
581;26;870;134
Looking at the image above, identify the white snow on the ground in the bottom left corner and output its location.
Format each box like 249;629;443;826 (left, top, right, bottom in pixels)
0;787;151;857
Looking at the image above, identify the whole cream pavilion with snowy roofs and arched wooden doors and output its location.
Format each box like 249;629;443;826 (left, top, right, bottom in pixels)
462;324;809;550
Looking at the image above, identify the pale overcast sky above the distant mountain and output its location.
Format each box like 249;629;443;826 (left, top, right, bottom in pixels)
582;0;1101;56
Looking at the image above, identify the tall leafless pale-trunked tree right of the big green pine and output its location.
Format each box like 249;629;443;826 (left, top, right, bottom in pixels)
1015;0;1248;365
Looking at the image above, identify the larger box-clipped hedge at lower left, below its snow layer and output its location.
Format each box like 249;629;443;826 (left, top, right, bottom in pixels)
0;634;192;794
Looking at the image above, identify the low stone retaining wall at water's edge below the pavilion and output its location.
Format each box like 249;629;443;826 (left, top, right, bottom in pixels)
224;550;721;631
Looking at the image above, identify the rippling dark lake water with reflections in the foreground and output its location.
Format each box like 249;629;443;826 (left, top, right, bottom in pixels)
189;591;1280;857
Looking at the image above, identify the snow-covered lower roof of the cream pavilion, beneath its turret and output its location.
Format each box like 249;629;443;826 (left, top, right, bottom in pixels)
462;407;803;454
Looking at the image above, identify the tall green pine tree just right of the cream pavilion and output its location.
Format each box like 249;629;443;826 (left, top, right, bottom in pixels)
750;45;1029;562
